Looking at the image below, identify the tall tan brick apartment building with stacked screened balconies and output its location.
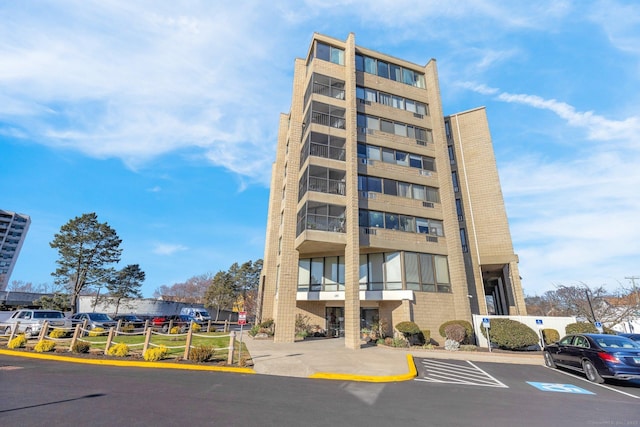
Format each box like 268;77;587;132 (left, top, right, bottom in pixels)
259;34;526;349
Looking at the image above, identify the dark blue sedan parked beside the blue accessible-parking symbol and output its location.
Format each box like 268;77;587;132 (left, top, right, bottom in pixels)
543;334;640;383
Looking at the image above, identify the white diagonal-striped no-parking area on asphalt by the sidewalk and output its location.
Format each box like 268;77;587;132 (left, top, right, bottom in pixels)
415;359;509;388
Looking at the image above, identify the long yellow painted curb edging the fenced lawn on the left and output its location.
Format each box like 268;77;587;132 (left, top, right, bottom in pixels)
0;349;256;374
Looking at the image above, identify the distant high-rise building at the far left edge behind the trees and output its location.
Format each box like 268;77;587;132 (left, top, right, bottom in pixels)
0;209;31;291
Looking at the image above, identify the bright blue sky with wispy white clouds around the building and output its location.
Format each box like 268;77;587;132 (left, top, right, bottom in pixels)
0;0;640;296
